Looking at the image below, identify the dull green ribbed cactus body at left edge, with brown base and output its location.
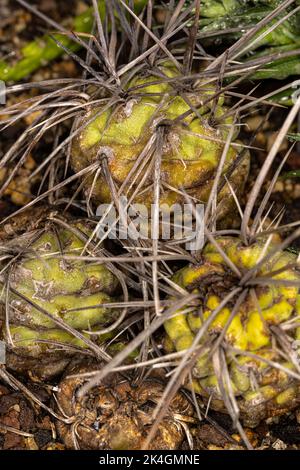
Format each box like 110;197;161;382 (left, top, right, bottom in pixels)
0;212;119;377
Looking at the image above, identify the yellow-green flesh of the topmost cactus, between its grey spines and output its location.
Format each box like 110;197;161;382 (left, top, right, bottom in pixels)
71;65;249;216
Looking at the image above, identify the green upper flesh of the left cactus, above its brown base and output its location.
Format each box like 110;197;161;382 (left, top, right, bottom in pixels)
0;225;118;353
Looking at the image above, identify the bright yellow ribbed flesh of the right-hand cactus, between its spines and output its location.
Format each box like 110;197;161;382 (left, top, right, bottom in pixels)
164;237;300;425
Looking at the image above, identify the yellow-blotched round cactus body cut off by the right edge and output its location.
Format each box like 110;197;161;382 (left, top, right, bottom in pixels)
165;237;300;427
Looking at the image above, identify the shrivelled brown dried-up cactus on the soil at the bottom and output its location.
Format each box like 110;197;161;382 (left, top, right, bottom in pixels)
56;362;193;450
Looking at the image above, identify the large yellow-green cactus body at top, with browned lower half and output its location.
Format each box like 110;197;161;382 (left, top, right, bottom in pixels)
71;63;249;222
